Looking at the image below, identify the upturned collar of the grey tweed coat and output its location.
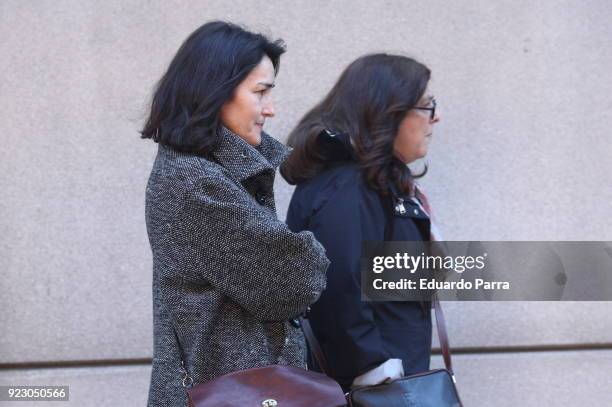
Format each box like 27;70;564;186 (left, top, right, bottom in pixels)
212;126;289;182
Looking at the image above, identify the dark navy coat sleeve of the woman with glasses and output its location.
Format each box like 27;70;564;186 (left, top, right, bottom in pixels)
288;175;392;383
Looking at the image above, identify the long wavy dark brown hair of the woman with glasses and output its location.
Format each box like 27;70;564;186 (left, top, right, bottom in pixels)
280;54;431;195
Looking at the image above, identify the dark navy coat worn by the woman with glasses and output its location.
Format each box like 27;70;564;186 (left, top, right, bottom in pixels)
287;153;431;390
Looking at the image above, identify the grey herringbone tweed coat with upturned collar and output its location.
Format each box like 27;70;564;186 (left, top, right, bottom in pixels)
146;128;329;406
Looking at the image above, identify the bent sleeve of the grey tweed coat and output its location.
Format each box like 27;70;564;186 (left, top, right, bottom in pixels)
173;177;329;321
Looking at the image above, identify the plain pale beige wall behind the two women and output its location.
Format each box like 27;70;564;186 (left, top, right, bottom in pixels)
0;0;612;406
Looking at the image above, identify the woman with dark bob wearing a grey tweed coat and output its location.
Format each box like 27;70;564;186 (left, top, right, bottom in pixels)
142;22;329;406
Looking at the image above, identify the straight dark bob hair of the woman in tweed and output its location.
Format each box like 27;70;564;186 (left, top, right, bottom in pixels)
140;21;285;155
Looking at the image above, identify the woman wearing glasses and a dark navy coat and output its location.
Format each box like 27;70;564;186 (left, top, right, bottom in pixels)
281;54;440;391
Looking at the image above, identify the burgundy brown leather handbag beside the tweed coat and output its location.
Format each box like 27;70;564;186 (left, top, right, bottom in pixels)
174;331;346;407
